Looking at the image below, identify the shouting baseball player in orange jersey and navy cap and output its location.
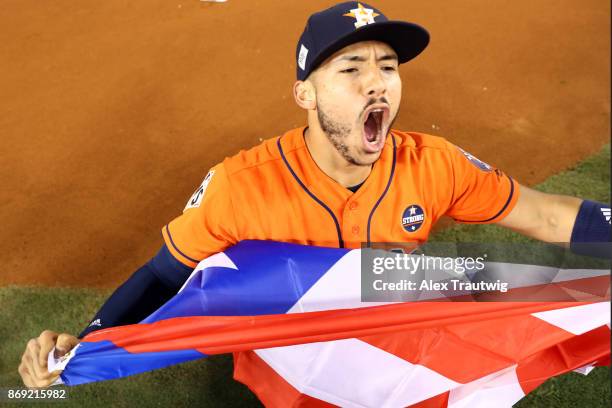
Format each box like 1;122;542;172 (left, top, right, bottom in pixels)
19;2;610;405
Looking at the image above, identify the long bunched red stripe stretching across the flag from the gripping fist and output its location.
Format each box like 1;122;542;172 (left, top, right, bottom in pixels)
83;302;580;354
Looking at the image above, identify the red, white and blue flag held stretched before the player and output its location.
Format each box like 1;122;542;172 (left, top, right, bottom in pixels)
49;241;610;408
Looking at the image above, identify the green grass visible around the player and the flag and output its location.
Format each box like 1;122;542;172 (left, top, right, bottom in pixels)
0;145;610;408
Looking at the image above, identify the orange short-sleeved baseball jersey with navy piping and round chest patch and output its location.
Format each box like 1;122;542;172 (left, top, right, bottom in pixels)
163;127;519;267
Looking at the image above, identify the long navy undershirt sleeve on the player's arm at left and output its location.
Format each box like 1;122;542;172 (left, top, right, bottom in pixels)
78;245;193;338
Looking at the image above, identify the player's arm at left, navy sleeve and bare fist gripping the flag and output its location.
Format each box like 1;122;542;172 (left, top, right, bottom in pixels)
19;245;192;387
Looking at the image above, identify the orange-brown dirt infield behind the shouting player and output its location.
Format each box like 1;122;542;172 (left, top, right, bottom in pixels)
0;0;610;287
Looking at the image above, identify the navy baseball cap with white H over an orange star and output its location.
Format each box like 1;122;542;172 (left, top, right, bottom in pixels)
295;1;429;81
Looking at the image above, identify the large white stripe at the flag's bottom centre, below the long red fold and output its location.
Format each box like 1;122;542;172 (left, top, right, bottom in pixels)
255;339;460;407
